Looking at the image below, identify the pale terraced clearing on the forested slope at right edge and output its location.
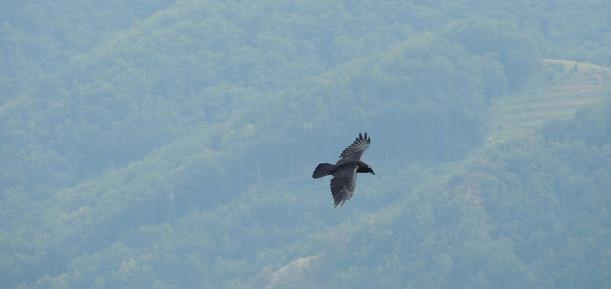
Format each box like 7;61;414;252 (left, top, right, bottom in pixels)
487;59;611;142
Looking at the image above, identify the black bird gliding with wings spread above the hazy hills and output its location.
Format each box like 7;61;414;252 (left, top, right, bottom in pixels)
312;133;375;207
